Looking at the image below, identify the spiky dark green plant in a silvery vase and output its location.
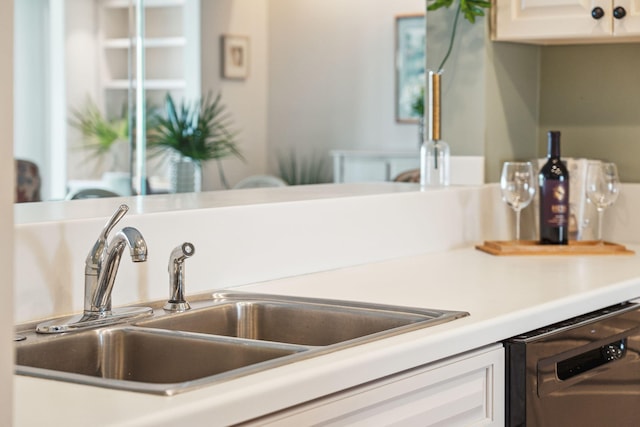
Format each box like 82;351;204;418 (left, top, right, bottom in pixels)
148;92;243;192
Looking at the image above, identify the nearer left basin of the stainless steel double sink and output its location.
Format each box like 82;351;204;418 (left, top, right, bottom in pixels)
16;327;306;394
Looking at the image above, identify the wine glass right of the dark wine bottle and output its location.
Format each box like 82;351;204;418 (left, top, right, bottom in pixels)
585;163;620;243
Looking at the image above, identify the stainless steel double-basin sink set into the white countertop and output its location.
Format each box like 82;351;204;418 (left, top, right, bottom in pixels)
15;292;468;395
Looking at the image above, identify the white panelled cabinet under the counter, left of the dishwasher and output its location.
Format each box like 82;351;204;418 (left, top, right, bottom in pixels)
246;344;504;427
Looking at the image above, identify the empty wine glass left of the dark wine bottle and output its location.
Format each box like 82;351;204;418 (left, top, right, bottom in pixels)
500;162;536;240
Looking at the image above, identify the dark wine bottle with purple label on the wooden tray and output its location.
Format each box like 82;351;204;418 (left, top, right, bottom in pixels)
538;131;569;245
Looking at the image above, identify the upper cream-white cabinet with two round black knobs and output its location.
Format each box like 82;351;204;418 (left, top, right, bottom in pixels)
492;0;640;44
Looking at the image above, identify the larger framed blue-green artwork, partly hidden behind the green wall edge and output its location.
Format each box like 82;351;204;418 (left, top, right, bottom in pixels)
395;14;427;123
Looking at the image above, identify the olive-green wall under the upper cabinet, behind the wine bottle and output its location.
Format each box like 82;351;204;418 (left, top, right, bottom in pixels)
538;44;640;182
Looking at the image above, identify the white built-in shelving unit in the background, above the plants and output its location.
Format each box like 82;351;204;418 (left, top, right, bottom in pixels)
98;0;201;116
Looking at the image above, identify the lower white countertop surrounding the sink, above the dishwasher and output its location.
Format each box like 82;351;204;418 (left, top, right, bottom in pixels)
15;245;640;426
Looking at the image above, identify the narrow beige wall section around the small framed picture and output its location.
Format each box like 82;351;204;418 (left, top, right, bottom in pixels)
200;0;269;190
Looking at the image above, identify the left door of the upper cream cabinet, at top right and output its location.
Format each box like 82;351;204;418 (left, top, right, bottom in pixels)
492;0;612;43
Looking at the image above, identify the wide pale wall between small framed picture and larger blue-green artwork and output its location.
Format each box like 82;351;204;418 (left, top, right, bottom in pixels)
268;0;425;176
